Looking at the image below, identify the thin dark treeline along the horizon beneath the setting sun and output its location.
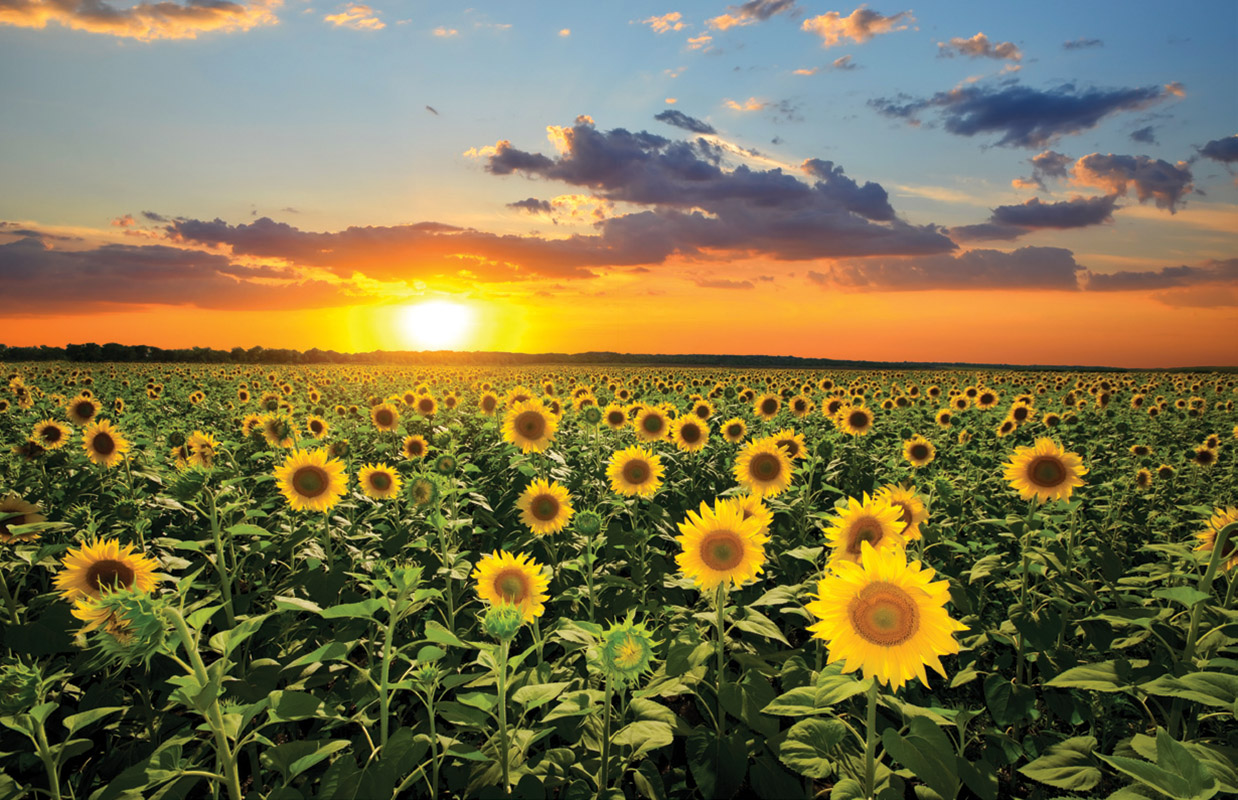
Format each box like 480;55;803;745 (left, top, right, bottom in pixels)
0;342;1223;372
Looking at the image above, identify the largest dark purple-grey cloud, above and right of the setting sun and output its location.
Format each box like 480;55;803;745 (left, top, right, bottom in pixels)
485;120;954;260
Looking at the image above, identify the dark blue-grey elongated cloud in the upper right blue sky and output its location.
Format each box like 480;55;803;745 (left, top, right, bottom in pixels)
869;83;1181;147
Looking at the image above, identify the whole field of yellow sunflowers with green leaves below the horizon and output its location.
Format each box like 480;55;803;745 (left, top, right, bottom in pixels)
0;363;1238;800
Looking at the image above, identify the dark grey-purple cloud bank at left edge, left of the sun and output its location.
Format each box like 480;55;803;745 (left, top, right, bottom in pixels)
0;238;347;315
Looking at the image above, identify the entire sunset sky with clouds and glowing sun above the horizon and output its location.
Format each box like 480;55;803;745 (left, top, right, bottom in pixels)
0;0;1238;368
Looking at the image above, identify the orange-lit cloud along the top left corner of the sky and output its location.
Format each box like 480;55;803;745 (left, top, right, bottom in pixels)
0;0;282;42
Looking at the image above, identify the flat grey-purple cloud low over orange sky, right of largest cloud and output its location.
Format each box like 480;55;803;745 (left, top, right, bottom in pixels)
808;248;1083;291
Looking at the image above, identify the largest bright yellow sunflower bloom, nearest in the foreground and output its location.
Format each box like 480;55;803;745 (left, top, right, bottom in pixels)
807;542;967;690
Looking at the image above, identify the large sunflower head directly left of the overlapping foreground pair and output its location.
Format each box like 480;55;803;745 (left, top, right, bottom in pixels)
675;499;769;592
